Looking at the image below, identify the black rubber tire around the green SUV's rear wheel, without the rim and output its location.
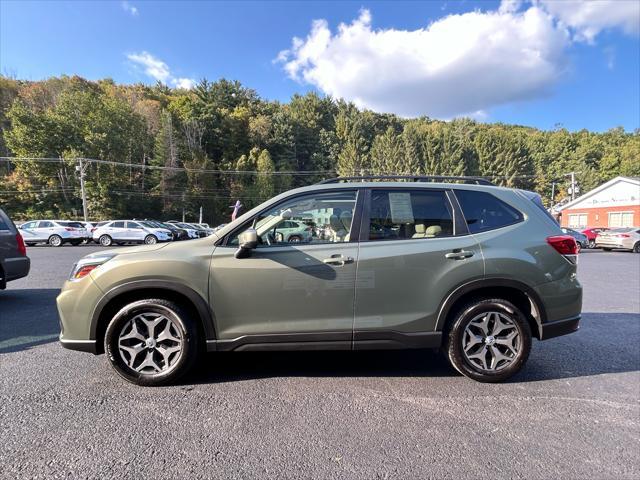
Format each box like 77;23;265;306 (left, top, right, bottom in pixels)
444;298;531;383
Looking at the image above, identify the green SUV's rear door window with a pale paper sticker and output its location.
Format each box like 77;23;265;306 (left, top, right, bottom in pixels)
369;189;453;241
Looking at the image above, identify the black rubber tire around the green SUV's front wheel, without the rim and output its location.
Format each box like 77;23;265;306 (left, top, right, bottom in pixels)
104;298;199;387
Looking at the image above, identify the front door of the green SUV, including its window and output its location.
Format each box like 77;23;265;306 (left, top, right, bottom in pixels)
209;189;360;349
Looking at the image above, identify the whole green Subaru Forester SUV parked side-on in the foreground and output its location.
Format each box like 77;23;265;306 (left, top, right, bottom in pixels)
57;177;582;385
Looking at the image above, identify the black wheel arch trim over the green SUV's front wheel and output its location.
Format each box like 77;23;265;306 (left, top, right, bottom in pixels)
90;280;216;353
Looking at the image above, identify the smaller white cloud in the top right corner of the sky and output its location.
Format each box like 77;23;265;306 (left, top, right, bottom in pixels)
539;0;640;43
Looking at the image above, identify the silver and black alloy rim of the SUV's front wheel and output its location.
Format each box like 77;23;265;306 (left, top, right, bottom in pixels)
118;312;183;374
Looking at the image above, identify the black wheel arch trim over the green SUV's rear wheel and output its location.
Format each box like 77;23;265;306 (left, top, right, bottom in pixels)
436;278;547;339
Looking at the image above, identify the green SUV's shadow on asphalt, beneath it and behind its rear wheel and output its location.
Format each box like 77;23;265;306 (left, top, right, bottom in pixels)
184;313;640;384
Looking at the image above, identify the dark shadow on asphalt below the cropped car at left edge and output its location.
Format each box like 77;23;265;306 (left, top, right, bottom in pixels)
0;288;60;355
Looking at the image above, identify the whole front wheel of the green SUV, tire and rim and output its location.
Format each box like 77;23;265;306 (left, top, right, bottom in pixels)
104;298;198;386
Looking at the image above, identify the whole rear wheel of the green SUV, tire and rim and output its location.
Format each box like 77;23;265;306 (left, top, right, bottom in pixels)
445;298;531;382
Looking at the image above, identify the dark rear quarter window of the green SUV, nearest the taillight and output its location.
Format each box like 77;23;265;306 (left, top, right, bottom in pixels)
455;190;524;233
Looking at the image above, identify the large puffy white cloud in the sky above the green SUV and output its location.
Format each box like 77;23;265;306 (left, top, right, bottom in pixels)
275;0;640;118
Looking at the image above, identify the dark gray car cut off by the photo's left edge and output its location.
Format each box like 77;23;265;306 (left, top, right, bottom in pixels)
0;208;31;288
